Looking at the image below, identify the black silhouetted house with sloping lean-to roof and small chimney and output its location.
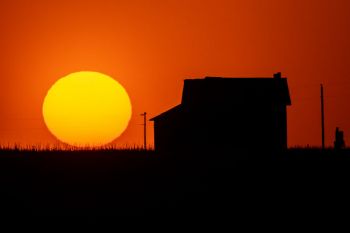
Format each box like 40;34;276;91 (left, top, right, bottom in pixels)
151;73;291;151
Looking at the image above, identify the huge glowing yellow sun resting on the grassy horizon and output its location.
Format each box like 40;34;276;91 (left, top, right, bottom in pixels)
42;71;132;147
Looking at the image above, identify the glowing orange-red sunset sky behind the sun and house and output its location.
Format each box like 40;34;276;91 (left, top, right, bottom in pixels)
0;0;350;146
